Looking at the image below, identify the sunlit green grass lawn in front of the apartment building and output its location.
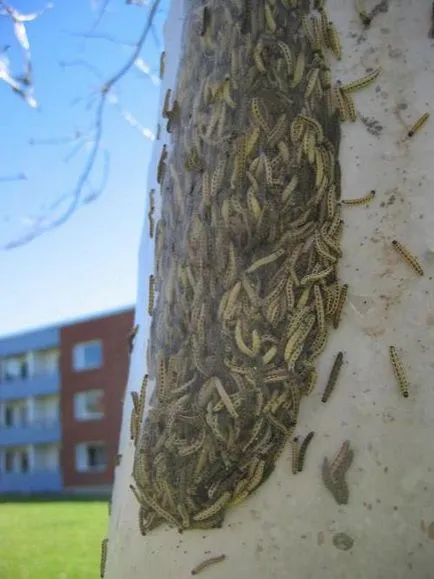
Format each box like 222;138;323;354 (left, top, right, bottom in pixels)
0;500;108;579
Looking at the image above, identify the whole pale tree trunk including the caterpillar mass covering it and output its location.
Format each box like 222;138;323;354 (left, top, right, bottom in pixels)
105;0;434;579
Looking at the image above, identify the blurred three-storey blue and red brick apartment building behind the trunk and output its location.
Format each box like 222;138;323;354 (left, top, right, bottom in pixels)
0;308;134;493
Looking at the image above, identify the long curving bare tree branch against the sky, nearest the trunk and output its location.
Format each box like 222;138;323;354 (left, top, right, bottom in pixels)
0;0;161;250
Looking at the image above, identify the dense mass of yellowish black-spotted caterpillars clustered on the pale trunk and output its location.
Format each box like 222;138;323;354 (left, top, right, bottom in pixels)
131;0;381;534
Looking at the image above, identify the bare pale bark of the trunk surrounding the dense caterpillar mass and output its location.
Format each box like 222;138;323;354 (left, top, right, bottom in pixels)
105;0;434;579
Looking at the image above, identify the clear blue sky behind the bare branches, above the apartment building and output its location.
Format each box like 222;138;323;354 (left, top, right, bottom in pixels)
0;0;168;335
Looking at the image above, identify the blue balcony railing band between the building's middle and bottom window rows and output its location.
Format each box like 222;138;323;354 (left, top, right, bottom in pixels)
0;420;61;446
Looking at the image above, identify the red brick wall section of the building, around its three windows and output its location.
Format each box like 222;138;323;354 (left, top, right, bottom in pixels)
60;310;134;487
